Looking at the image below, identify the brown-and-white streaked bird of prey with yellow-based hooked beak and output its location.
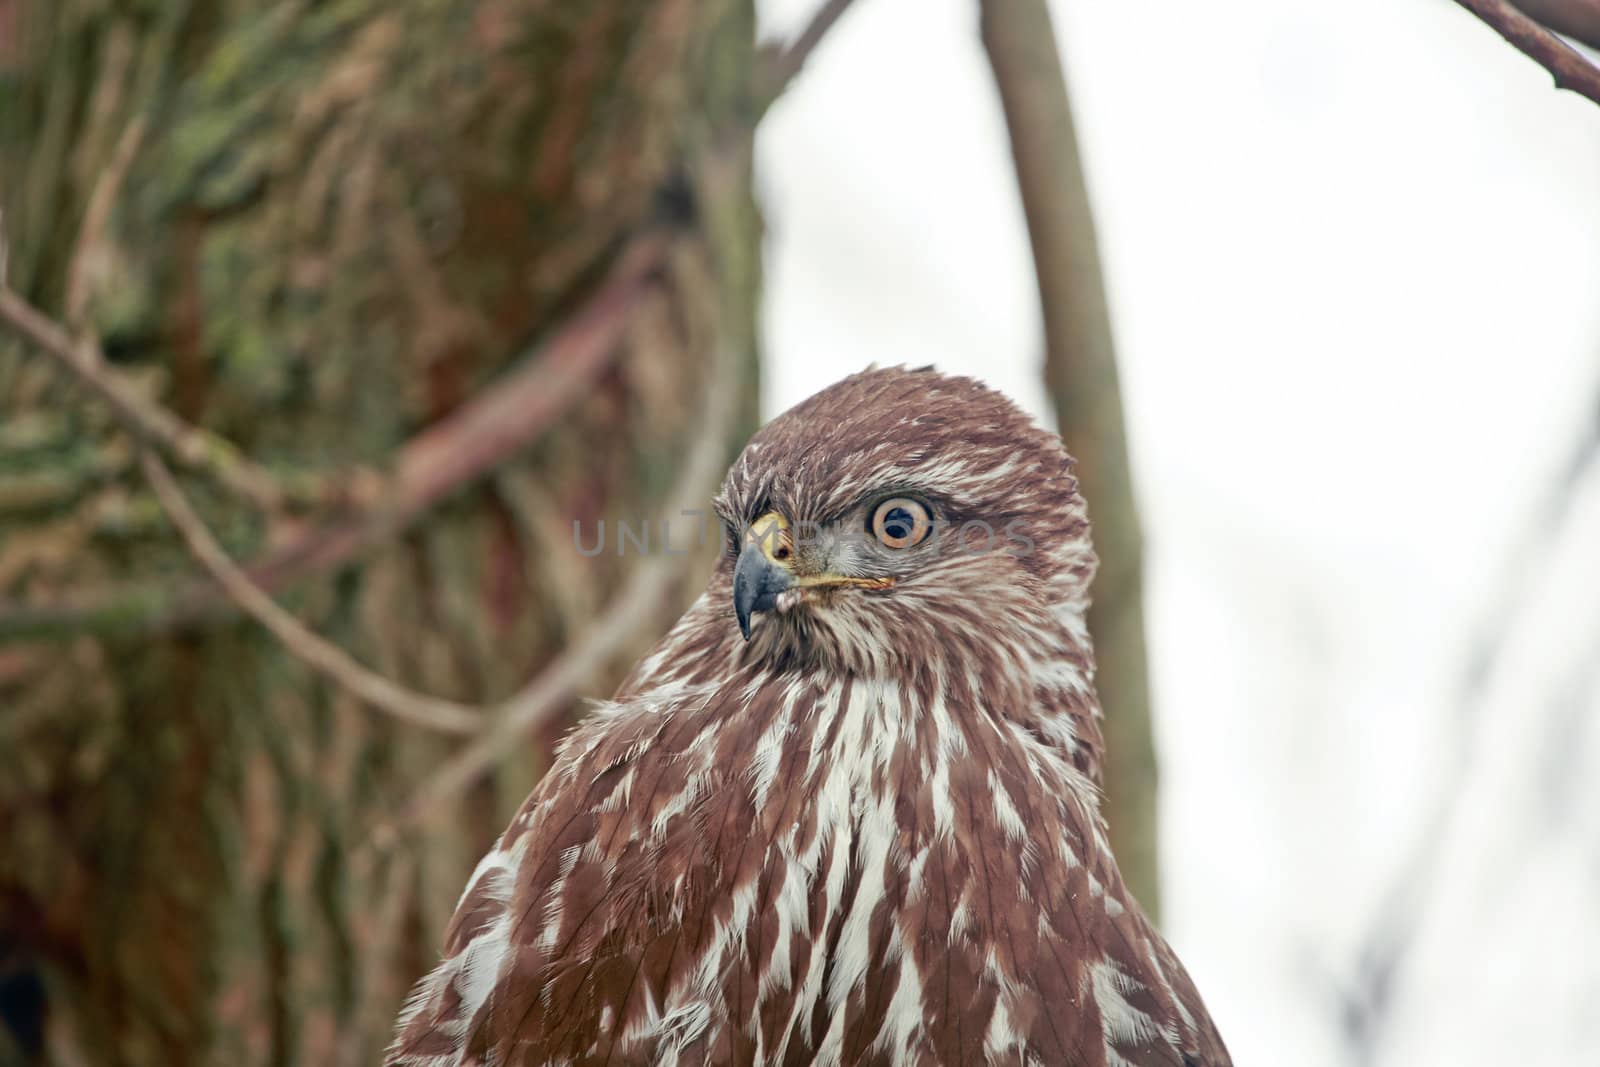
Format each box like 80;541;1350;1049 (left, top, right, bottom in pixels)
389;368;1230;1067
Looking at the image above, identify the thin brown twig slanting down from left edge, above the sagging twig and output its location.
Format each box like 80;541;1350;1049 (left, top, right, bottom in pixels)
0;288;299;510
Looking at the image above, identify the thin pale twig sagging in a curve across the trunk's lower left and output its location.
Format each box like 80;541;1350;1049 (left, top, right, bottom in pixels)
139;448;482;734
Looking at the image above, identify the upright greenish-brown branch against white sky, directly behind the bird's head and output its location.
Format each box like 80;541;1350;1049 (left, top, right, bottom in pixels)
981;0;1160;913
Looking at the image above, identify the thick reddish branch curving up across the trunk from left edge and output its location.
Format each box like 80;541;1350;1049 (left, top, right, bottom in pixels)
0;234;669;635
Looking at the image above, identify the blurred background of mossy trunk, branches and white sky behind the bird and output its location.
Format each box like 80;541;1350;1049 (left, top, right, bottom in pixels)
0;0;1600;1067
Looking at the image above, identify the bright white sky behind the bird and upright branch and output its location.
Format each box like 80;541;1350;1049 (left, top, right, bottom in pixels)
758;0;1600;1067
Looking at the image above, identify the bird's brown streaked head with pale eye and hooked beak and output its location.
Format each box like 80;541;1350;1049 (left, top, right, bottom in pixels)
715;368;1094;672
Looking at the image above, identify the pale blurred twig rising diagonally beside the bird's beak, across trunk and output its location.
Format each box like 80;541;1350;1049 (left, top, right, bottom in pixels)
370;342;736;849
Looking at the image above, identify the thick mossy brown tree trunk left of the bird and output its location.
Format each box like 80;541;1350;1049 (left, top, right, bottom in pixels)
0;0;758;1064
